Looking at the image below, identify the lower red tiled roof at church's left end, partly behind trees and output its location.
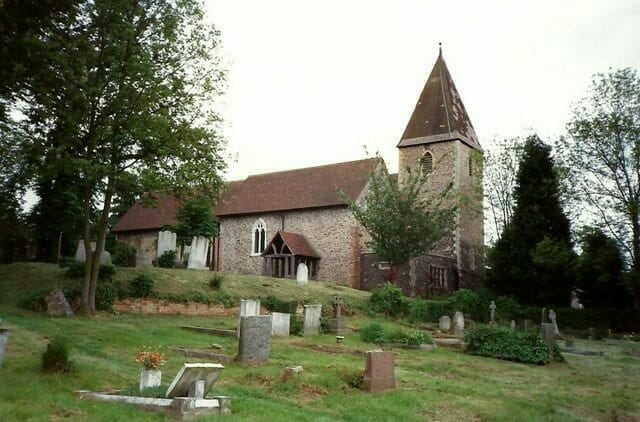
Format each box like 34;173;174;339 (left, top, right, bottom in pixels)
111;195;180;233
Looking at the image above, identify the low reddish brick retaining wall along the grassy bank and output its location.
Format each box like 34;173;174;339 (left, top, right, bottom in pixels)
113;299;238;316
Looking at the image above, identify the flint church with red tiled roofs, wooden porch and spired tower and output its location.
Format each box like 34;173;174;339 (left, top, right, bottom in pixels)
112;46;484;296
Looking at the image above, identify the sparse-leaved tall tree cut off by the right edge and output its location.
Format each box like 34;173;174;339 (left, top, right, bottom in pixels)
562;68;640;294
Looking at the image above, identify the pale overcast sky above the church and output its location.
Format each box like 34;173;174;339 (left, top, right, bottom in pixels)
206;0;640;179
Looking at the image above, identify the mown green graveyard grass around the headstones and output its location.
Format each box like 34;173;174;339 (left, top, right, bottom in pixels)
0;264;640;421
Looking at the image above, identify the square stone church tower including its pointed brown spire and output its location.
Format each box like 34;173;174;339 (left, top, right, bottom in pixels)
397;48;484;291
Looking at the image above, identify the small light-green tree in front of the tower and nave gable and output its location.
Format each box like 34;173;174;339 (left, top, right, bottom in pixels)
343;164;455;265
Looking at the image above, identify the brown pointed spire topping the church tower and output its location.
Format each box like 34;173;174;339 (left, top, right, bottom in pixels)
398;43;480;149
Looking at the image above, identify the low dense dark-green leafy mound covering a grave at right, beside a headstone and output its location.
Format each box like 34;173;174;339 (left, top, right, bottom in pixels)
465;327;551;365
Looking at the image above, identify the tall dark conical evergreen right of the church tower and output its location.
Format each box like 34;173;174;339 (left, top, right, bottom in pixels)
487;135;574;305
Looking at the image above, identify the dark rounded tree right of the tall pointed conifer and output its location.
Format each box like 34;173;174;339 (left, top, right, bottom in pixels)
577;228;632;307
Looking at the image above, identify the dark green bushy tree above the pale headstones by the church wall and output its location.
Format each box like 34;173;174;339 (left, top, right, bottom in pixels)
173;196;218;244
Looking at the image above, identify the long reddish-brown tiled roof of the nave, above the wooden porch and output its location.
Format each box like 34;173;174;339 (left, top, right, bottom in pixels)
215;158;382;217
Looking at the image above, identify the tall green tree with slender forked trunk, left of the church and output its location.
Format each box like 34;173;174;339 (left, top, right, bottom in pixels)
13;0;225;313
